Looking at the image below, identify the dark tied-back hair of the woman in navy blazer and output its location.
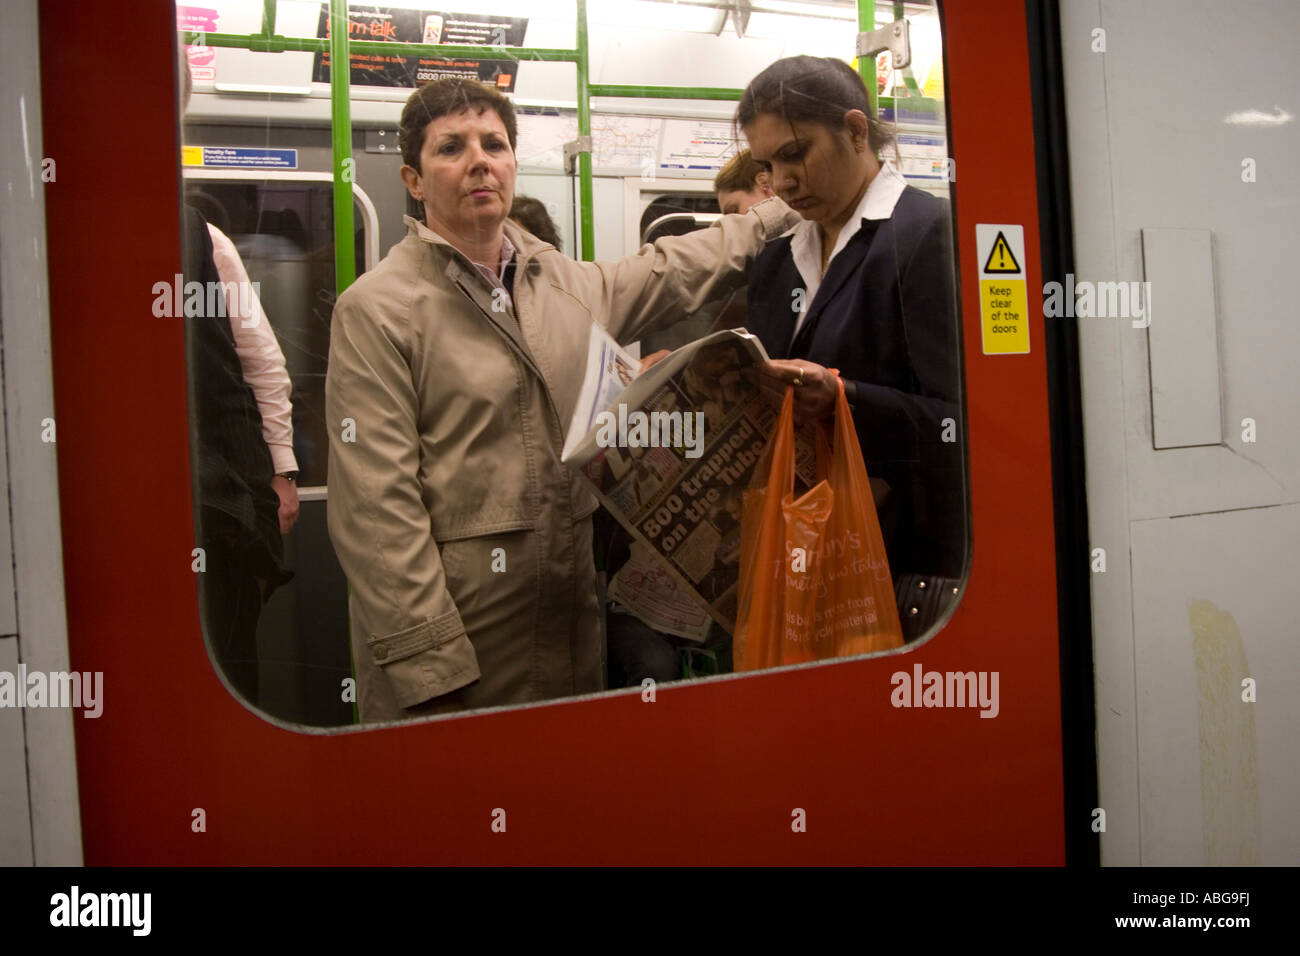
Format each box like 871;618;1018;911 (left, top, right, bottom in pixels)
735;56;894;156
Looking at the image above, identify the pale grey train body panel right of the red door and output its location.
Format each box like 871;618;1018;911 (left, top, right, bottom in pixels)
1066;0;1300;865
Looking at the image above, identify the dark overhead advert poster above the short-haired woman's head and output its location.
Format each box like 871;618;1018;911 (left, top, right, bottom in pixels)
312;4;528;92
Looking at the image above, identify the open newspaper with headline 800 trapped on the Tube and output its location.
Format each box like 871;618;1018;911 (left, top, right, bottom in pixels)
563;325;815;640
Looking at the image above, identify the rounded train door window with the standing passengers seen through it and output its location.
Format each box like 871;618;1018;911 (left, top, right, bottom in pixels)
178;0;969;726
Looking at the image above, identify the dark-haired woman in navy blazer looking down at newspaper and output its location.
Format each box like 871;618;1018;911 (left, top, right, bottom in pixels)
736;56;966;636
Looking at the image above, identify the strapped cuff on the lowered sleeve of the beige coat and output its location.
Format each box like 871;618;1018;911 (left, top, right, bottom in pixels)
367;610;480;708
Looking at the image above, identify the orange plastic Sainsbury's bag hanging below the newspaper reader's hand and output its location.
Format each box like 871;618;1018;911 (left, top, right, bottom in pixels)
735;382;904;671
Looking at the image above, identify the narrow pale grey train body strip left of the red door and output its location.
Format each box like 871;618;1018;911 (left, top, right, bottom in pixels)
0;0;83;866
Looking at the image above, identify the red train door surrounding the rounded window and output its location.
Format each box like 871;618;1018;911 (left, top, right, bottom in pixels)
40;0;1065;865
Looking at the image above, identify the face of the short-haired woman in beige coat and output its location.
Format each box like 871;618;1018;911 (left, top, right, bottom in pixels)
402;105;517;241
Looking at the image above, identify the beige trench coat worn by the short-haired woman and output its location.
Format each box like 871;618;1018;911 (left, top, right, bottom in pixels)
325;199;798;722
